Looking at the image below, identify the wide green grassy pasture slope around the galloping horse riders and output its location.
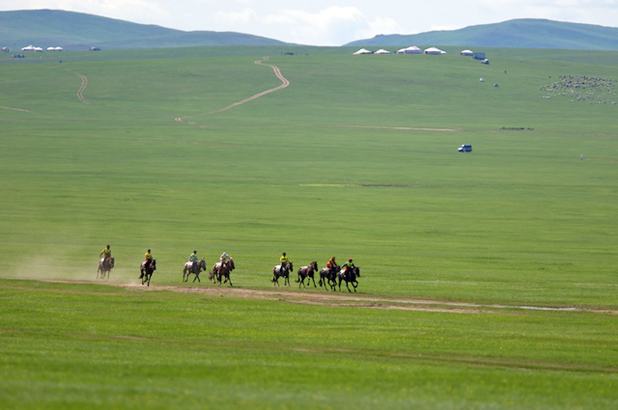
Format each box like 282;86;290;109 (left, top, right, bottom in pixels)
0;48;618;410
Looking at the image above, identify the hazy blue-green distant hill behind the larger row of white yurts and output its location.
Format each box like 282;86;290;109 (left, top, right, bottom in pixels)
346;19;618;50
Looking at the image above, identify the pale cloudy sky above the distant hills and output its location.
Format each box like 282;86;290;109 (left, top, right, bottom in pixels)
0;0;618;46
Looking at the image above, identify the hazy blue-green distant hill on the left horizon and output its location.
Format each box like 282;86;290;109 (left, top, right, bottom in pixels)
0;10;286;50
